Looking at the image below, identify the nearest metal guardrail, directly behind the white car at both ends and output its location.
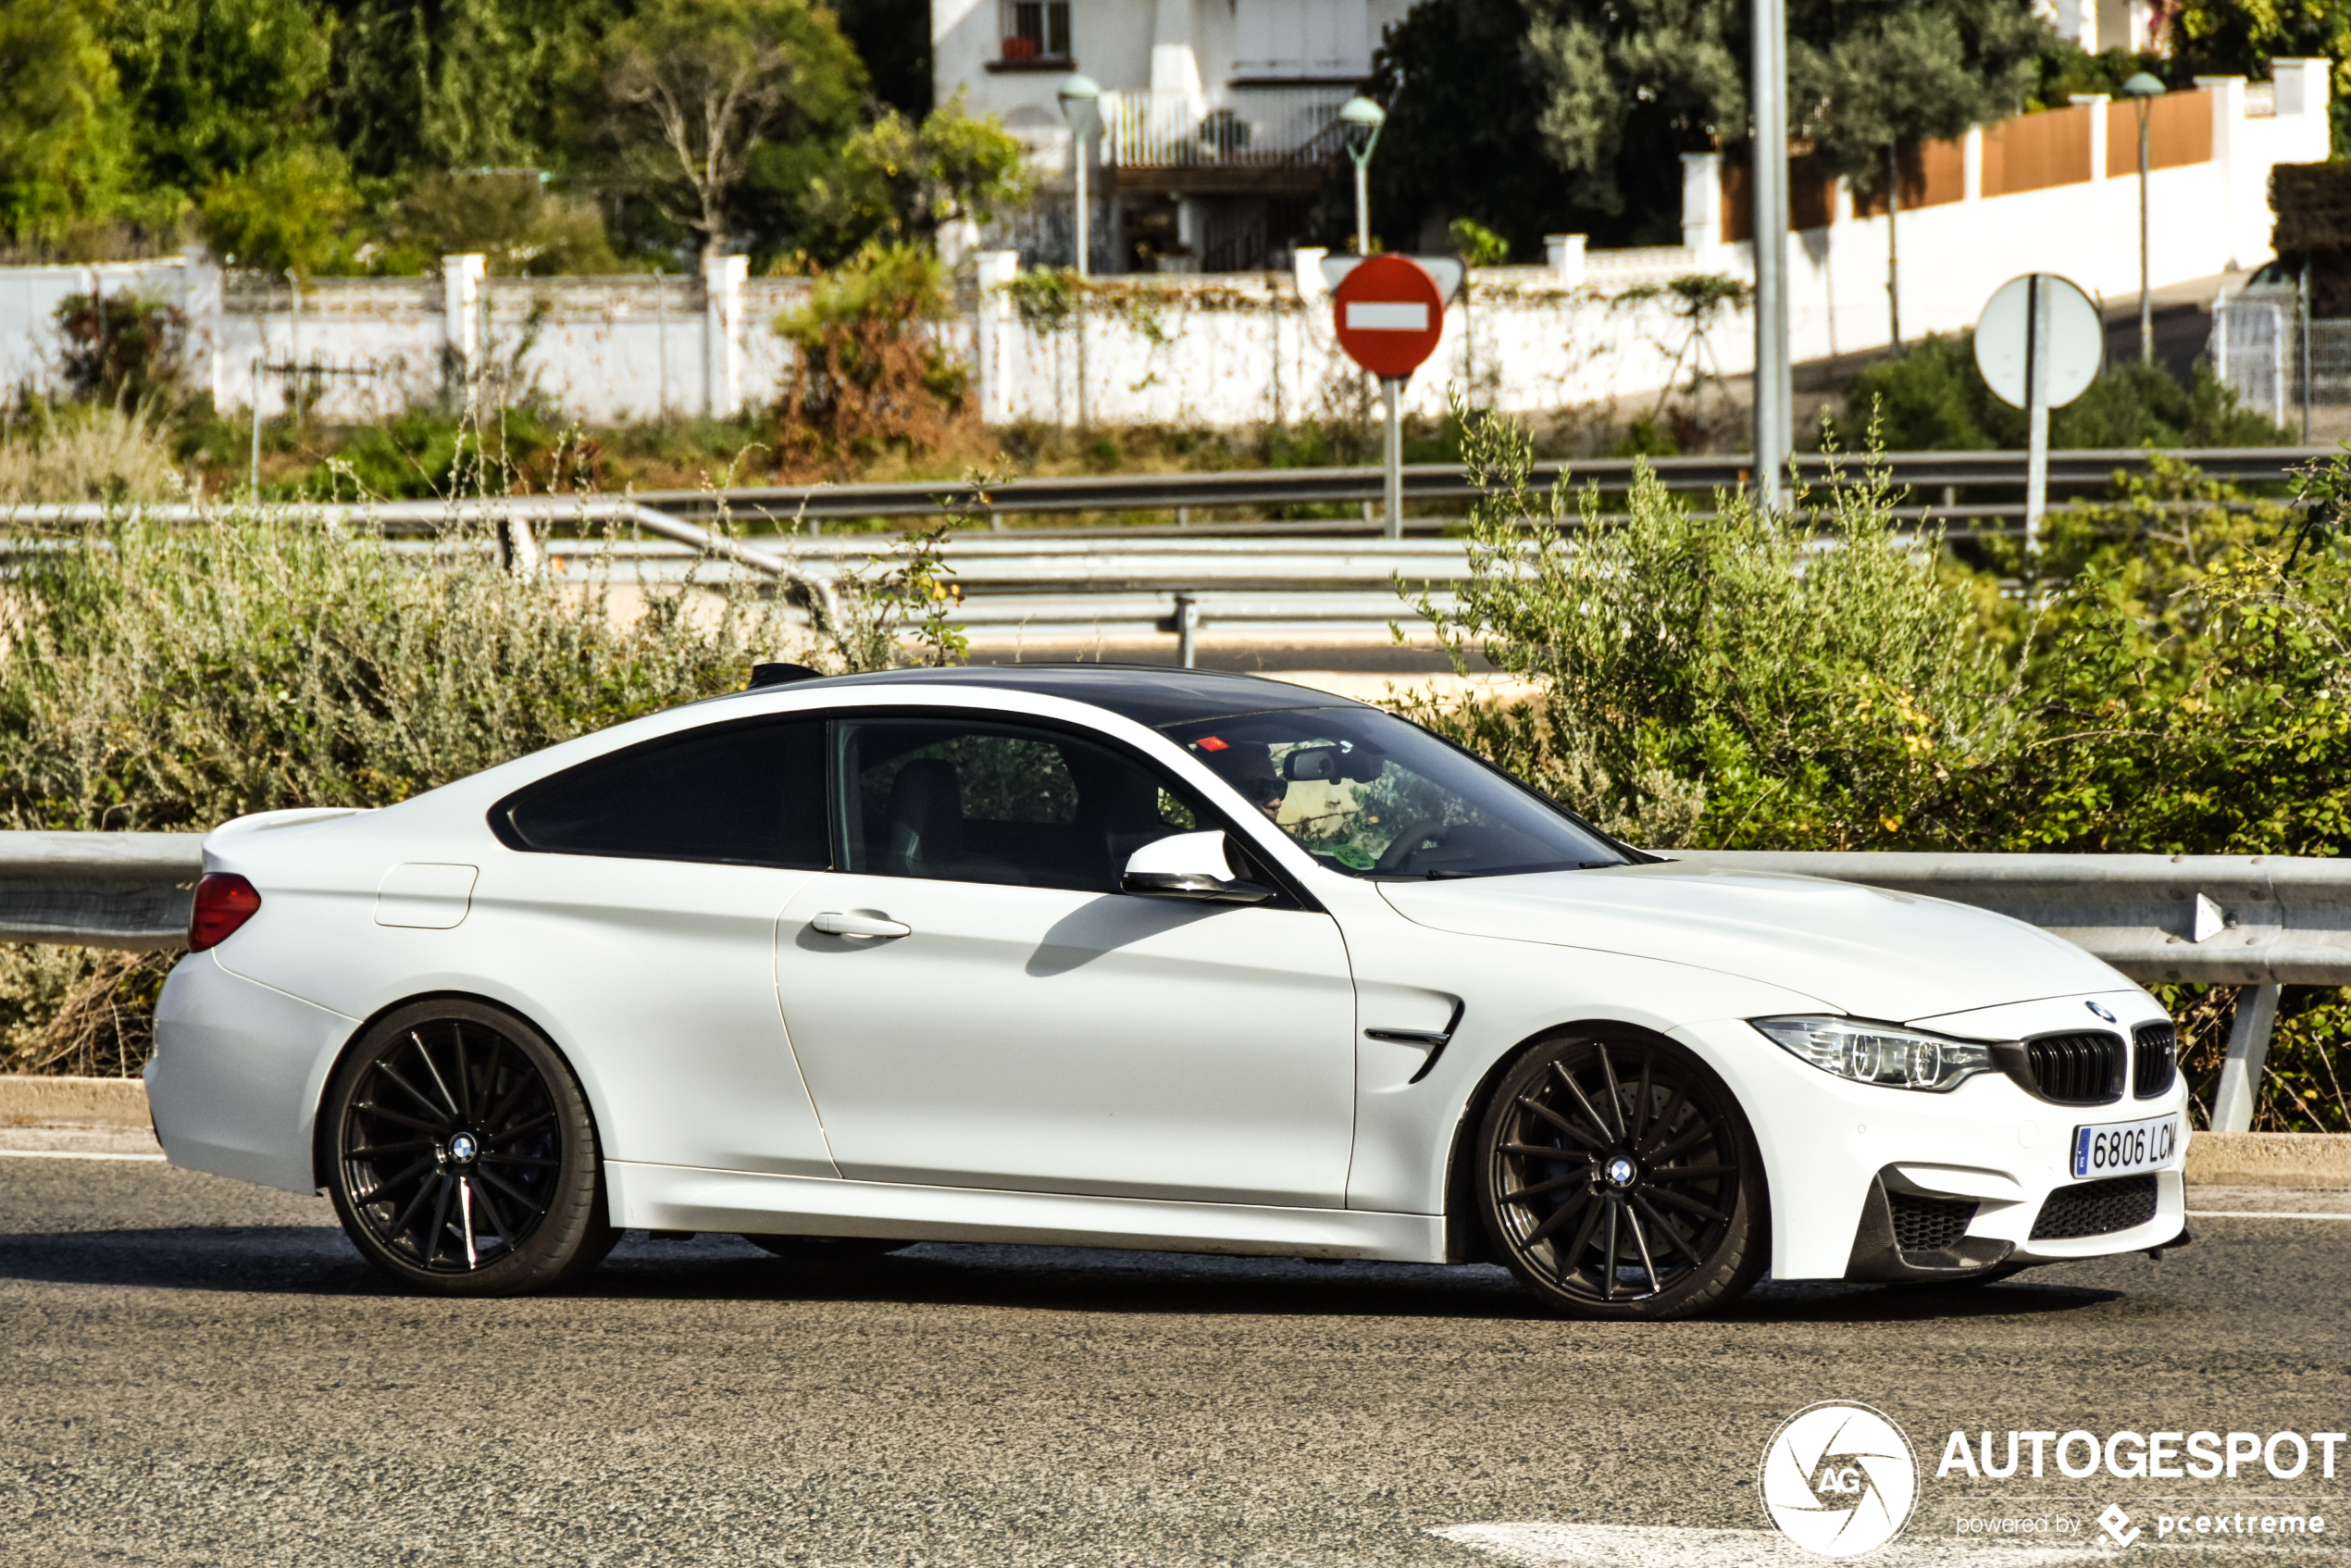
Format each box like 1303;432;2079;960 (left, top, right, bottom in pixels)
0;832;2351;1131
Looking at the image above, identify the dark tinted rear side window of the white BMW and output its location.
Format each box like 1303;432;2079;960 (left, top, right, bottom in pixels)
491;719;832;870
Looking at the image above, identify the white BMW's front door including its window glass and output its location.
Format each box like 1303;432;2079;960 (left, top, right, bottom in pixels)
776;715;1354;1208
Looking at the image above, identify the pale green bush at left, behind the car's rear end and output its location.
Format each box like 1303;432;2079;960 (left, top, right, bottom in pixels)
0;510;785;830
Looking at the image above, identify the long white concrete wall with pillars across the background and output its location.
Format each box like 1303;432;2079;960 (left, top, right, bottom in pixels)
0;65;2328;426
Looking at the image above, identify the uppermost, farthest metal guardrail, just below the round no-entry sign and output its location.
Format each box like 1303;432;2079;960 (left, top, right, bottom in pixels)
635;447;2337;522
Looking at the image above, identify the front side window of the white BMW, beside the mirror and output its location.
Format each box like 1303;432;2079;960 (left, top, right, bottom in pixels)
835;719;1206;893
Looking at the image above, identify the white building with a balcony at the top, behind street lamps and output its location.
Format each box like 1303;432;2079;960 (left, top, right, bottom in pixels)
931;0;1411;273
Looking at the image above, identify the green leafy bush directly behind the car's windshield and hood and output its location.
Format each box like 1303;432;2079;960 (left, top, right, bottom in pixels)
1418;417;2012;849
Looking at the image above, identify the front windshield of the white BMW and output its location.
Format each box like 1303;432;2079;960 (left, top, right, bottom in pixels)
1166;707;1629;877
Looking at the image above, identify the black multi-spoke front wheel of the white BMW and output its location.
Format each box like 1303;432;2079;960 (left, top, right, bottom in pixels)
1476;1034;1771;1319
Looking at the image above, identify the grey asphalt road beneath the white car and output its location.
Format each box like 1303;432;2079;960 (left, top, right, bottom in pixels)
0;1157;2351;1568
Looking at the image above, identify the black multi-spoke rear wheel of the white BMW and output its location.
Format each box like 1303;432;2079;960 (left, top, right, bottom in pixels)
327;999;618;1295
